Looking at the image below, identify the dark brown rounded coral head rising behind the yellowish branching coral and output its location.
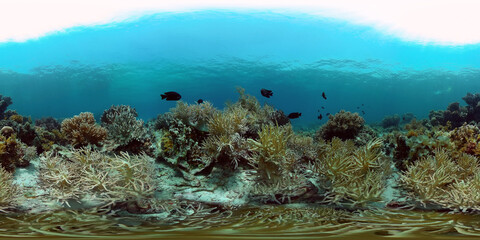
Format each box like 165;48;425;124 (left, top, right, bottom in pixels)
319;110;365;140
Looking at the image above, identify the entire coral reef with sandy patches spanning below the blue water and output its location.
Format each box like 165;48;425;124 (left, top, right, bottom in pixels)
0;88;480;234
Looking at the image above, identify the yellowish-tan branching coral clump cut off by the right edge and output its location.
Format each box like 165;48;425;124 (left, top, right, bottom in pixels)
401;149;480;210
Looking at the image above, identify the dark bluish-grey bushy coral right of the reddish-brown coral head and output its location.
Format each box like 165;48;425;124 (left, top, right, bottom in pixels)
101;105;147;153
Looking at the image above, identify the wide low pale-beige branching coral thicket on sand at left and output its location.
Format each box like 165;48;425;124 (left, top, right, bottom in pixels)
39;149;157;206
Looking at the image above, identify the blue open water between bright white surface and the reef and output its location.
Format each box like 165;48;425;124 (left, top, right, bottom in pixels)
0;11;480;125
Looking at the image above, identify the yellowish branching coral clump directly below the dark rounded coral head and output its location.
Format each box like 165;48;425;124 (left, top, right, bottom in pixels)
312;137;391;205
